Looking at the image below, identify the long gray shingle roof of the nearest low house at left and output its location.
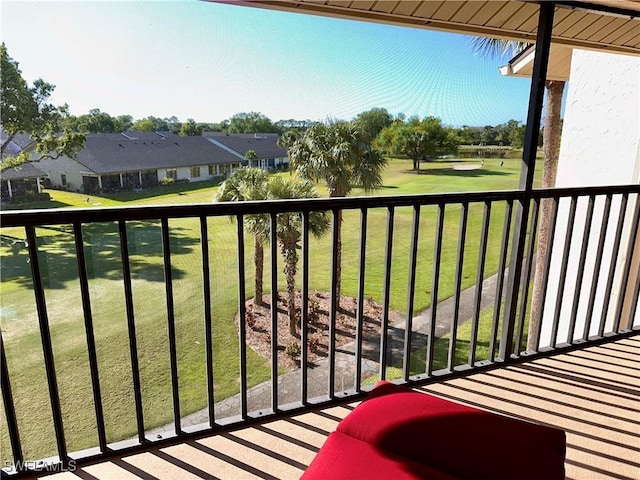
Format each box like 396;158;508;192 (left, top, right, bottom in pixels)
76;132;239;173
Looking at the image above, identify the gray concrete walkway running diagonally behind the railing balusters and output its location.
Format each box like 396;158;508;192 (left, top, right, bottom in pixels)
147;274;498;438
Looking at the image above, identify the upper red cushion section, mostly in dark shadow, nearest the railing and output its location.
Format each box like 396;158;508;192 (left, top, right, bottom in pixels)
337;382;565;480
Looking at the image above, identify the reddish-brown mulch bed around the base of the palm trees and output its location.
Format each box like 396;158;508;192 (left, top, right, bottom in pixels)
236;291;382;369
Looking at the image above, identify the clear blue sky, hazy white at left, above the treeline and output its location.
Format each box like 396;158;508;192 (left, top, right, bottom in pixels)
0;0;530;126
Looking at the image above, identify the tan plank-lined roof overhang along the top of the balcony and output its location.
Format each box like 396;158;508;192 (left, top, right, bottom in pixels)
214;0;640;55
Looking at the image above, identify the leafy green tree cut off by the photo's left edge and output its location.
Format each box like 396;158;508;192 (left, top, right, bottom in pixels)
0;43;86;170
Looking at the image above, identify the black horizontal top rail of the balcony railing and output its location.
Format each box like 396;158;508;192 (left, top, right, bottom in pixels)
0;184;640;227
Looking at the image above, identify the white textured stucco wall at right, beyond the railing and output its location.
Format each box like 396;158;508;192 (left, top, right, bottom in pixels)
540;50;640;347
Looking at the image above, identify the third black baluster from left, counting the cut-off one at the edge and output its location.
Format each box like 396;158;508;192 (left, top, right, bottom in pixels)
73;223;107;452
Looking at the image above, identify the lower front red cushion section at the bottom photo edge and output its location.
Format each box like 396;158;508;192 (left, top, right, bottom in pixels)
301;432;455;480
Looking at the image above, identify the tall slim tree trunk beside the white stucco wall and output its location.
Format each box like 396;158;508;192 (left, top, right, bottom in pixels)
527;80;564;350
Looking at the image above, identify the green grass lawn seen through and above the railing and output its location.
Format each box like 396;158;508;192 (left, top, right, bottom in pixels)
0;156;536;460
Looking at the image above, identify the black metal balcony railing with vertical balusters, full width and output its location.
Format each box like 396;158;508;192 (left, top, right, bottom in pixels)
0;185;640;474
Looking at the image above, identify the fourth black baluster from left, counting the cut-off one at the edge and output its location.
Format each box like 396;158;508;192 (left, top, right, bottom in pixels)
118;220;146;443
